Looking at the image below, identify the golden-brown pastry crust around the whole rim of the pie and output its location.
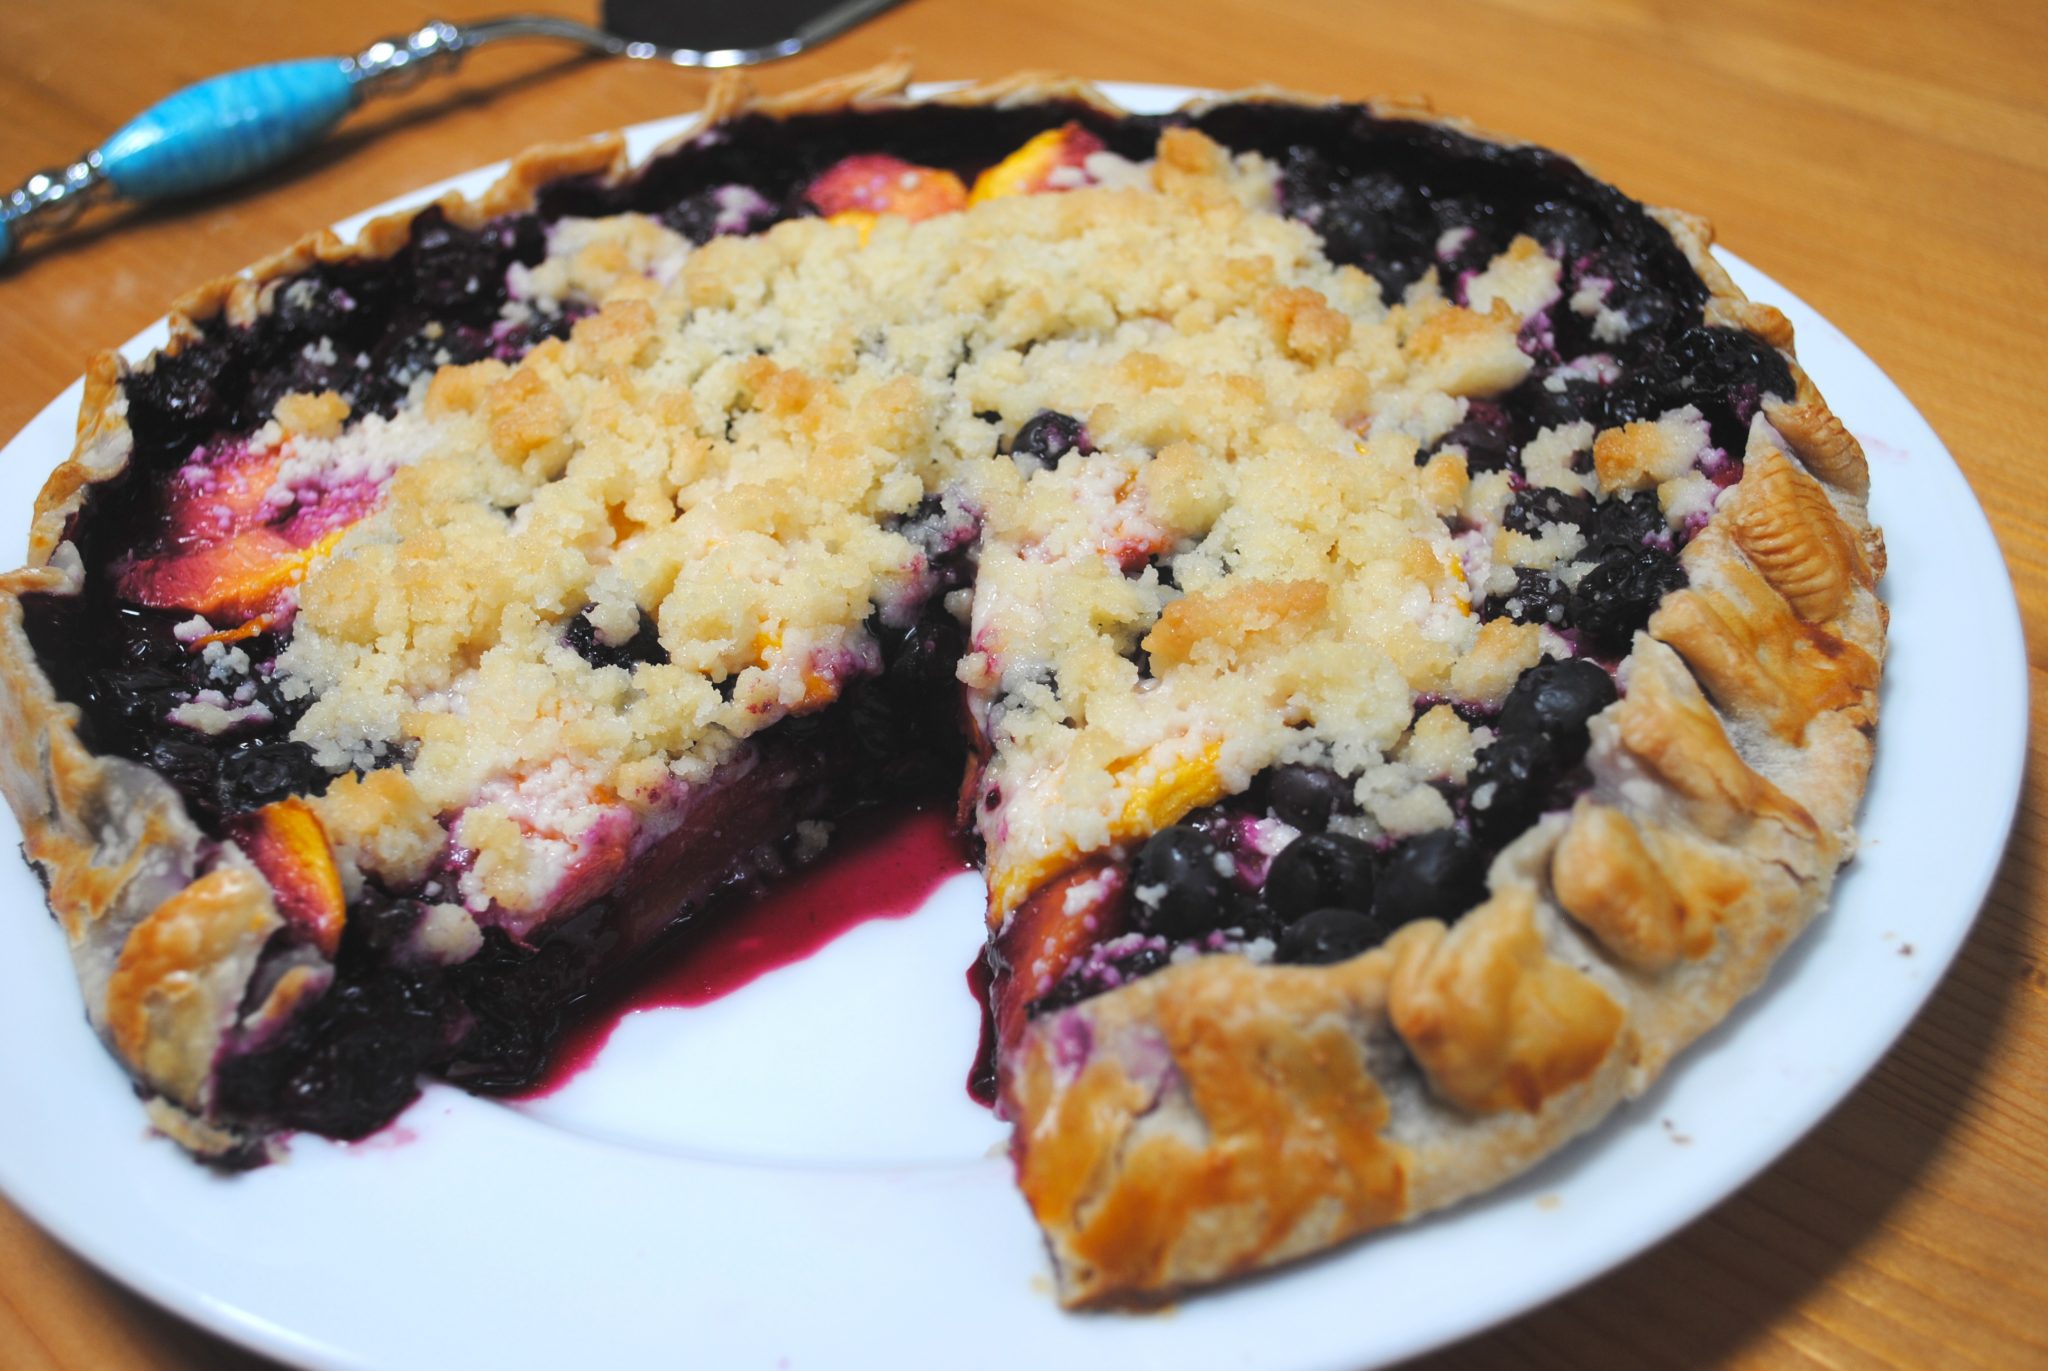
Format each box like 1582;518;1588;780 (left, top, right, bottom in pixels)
0;64;1886;1305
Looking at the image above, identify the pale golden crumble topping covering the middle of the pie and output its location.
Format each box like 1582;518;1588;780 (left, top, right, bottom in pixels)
199;129;1704;928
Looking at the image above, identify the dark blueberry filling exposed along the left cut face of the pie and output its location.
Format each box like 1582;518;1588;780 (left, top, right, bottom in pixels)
219;654;965;1137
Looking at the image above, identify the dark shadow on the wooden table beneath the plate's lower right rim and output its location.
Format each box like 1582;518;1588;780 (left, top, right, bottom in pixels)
1403;750;2044;1371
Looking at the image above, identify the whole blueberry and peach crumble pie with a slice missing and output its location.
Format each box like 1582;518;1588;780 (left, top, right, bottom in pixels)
0;74;1882;1299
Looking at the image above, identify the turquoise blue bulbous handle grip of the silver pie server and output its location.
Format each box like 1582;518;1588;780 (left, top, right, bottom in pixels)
100;57;356;201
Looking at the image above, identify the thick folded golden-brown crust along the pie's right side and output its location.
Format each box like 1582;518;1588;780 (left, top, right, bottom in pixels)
1006;152;1884;1305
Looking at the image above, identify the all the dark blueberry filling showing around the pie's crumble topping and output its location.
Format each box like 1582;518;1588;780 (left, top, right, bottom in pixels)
23;102;1792;1137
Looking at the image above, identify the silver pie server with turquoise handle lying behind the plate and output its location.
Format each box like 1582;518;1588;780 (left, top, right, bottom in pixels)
0;0;899;262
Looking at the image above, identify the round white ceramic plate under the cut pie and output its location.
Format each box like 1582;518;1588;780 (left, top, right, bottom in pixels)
0;86;2025;1371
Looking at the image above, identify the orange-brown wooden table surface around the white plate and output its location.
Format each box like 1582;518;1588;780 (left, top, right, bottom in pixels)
0;0;2048;1371
